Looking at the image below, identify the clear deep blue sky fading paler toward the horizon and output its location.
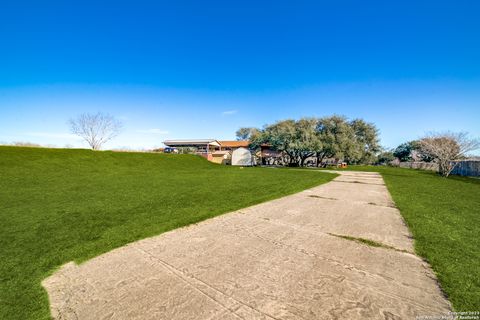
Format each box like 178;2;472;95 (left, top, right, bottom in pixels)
0;0;480;148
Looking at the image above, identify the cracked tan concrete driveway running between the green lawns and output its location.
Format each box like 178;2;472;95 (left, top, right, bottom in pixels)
43;172;451;320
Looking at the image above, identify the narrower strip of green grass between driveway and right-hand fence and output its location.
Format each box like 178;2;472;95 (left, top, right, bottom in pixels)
334;166;480;311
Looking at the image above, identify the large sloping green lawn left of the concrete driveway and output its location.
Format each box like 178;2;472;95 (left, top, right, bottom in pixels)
0;147;335;319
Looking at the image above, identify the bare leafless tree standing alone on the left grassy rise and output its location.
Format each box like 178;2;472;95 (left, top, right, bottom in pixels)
68;112;122;150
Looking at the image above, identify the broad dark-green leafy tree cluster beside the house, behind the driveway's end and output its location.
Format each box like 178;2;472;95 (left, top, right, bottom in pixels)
246;115;381;166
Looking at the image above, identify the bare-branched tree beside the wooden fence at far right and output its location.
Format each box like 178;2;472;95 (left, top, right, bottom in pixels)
420;132;480;177
